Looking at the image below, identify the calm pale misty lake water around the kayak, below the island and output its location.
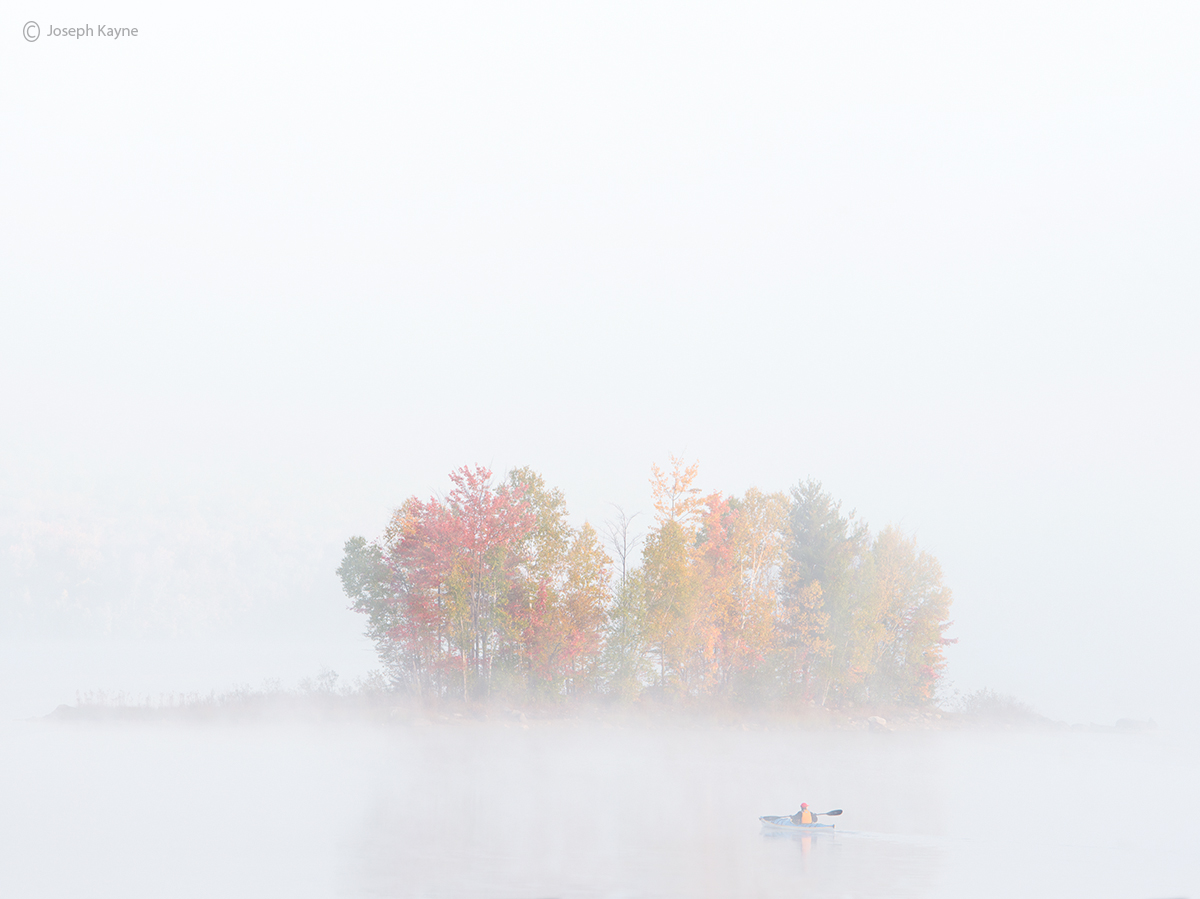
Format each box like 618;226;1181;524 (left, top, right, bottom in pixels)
0;720;1200;899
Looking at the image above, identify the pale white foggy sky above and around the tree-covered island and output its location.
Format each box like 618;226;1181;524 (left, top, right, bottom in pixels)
0;2;1200;723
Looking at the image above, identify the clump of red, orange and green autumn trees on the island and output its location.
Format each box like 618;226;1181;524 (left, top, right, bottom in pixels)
337;459;952;705
